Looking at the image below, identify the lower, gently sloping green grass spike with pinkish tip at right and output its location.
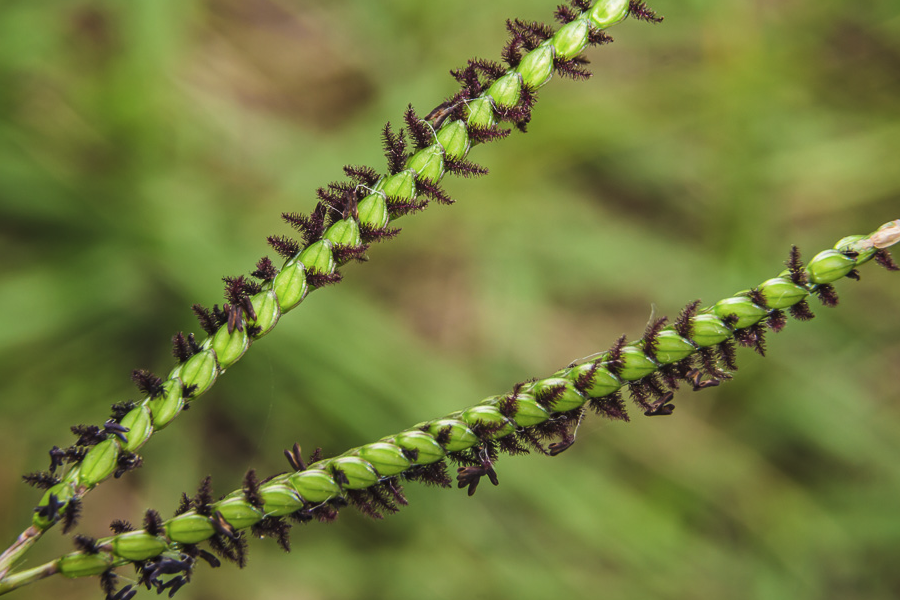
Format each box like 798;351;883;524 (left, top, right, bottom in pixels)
44;227;900;598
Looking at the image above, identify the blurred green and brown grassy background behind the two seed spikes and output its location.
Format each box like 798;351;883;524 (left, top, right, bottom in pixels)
0;0;900;600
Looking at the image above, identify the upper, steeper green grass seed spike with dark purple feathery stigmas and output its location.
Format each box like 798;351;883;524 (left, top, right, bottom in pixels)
19;0;659;531
